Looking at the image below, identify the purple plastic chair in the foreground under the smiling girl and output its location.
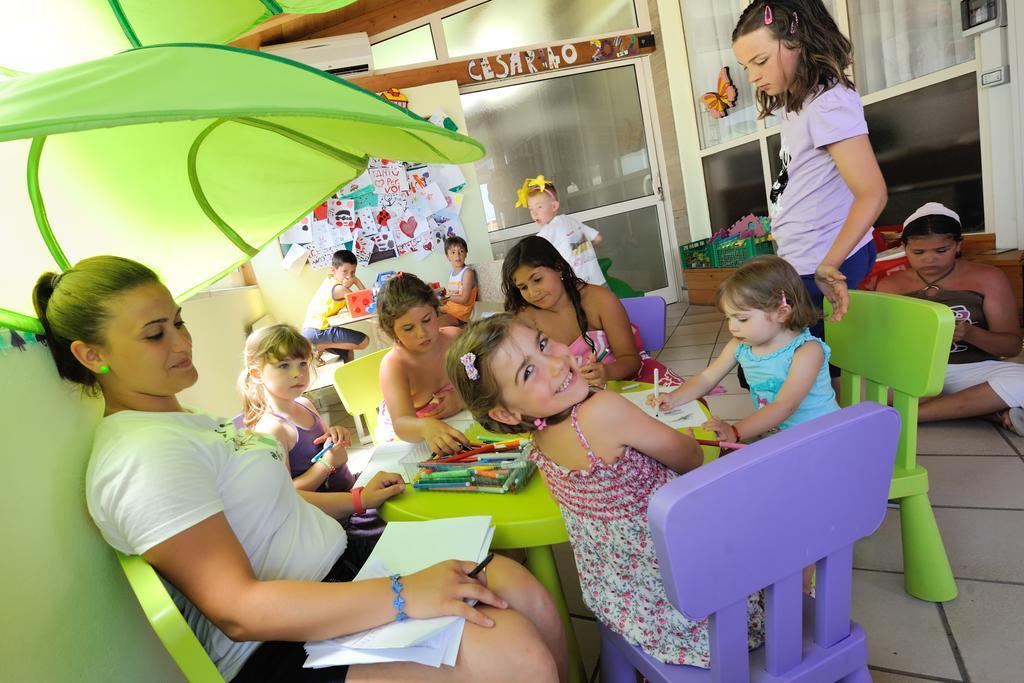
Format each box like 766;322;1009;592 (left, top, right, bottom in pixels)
601;402;899;683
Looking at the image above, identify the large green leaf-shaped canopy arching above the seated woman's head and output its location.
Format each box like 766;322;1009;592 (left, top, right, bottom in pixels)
0;45;483;330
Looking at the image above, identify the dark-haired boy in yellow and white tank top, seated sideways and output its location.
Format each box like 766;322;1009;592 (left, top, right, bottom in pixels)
302;249;370;362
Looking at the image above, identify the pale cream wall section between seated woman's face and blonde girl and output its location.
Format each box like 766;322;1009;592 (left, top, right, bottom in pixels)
178;287;264;417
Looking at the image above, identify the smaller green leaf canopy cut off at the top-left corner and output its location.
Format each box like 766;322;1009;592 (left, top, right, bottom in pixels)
0;0;354;73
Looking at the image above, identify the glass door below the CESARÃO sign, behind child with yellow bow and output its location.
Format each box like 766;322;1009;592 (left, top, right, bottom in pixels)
462;60;678;302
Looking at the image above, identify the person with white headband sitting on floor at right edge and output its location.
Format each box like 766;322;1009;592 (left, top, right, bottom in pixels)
878;202;1024;435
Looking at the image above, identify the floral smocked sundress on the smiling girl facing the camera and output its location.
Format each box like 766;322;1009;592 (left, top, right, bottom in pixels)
529;405;764;669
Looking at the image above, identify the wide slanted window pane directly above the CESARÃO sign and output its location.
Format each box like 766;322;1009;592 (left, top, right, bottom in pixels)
441;0;638;58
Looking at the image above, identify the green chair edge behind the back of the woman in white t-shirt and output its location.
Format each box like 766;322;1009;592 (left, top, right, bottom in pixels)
114;551;224;683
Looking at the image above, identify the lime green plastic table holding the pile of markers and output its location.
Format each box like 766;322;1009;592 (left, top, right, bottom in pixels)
379;382;718;682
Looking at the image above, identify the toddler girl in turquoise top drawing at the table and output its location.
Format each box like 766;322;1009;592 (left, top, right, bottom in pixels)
651;256;839;441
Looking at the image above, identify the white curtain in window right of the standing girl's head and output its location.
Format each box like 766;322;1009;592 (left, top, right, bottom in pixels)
848;0;974;95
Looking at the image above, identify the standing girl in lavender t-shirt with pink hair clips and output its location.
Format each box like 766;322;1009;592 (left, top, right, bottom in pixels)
732;0;887;327
